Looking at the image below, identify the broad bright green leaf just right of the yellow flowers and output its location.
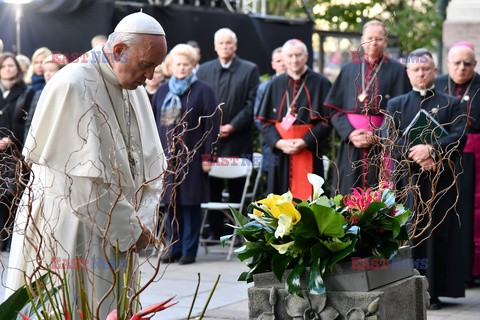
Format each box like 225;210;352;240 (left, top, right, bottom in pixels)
310;204;346;238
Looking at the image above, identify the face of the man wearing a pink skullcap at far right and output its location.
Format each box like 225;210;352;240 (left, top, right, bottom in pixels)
447;47;477;84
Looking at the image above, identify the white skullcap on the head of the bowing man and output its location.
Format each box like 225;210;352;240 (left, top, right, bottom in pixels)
114;12;165;36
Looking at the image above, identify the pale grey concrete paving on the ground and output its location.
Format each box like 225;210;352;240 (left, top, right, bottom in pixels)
0;248;480;320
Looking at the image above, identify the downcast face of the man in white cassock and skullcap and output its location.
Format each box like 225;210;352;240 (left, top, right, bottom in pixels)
112;35;167;90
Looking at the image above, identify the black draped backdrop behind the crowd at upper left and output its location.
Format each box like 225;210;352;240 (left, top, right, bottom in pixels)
0;0;313;74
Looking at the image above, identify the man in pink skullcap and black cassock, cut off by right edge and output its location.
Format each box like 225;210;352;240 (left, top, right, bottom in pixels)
435;41;480;283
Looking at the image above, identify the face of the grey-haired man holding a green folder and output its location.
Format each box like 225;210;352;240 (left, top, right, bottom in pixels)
407;55;437;89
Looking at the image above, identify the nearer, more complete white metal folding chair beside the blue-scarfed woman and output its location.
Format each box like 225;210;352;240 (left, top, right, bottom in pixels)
200;157;253;260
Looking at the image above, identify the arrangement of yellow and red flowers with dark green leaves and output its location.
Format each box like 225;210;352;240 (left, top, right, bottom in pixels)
222;174;410;296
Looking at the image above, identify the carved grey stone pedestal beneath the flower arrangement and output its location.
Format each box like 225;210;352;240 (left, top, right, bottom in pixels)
248;271;429;320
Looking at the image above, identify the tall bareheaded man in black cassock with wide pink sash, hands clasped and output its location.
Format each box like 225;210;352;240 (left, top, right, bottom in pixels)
325;20;411;194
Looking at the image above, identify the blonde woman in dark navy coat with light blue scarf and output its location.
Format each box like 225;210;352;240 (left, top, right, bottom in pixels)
152;44;220;264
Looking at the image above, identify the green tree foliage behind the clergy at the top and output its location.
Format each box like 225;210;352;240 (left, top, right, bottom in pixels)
268;0;443;52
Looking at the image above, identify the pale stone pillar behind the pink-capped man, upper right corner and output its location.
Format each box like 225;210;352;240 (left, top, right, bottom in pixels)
442;0;480;72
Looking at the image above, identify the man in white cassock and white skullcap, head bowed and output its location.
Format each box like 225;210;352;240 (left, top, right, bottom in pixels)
6;12;167;319
